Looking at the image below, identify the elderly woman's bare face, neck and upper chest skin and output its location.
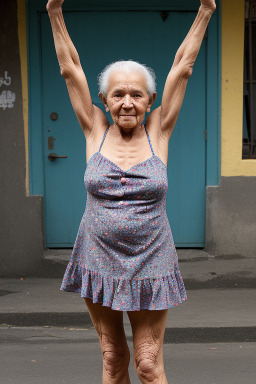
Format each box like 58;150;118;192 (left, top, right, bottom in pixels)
97;72;158;169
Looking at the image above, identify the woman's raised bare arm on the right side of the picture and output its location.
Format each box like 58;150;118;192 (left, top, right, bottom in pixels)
160;0;216;138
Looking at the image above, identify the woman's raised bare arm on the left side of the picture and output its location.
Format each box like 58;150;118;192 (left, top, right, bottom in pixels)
46;0;99;137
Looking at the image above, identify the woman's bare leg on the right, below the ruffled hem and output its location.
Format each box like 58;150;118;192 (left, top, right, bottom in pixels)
127;309;168;384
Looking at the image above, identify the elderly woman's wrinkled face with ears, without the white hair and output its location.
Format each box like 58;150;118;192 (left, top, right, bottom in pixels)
99;72;156;130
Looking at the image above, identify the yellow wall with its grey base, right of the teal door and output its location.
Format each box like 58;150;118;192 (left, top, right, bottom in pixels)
206;0;256;257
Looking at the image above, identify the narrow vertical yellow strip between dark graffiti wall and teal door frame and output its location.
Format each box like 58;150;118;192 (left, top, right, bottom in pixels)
17;0;29;195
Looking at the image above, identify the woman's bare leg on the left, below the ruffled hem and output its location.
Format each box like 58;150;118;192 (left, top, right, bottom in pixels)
84;298;131;384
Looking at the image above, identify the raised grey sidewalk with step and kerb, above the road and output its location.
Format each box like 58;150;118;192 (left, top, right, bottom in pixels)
0;249;256;343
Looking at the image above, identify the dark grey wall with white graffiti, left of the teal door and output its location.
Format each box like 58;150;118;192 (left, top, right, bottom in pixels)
0;0;44;276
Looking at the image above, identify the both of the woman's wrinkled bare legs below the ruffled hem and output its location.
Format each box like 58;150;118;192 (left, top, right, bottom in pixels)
84;298;168;384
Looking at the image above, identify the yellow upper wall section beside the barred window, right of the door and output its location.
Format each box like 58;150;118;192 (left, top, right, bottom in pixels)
221;0;256;176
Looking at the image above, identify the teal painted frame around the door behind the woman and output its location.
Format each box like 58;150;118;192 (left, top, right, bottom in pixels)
26;0;221;246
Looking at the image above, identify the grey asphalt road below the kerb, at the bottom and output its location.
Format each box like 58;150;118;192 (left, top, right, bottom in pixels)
0;327;256;384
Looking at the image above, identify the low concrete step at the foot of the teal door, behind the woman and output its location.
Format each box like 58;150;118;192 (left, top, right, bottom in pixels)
40;248;256;290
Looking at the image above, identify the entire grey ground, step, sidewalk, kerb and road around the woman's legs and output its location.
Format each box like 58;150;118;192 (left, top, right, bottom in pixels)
0;249;256;384
